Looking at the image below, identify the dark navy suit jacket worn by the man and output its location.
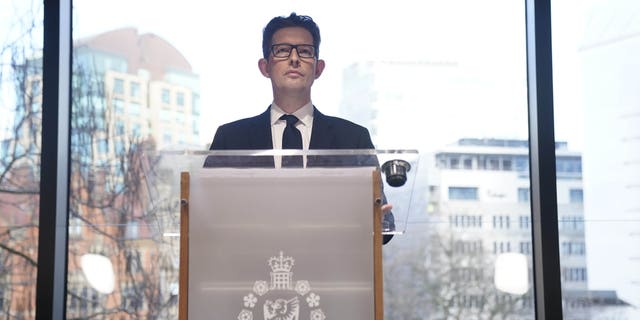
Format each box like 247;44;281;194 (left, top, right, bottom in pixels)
204;107;394;243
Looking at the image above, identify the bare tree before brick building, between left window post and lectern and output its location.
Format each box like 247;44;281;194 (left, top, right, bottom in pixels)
62;51;179;319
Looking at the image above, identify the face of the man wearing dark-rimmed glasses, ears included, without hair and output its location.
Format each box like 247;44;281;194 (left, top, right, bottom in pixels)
258;27;324;94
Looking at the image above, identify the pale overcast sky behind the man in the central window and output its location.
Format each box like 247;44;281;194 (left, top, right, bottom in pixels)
69;0;582;150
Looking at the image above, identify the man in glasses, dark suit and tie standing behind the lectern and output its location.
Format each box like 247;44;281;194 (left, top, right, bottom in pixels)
205;13;393;242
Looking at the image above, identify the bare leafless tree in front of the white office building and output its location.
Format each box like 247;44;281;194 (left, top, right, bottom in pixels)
384;224;533;319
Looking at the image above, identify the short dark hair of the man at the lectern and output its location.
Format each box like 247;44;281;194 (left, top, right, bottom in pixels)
262;12;320;59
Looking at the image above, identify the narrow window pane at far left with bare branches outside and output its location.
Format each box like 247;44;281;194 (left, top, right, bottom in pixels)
0;0;43;319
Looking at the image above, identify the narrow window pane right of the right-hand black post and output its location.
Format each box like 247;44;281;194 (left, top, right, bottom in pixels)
551;0;640;319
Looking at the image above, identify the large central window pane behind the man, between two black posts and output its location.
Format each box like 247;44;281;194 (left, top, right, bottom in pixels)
67;0;532;319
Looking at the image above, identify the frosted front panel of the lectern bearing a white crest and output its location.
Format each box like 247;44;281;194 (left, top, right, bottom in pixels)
185;167;375;320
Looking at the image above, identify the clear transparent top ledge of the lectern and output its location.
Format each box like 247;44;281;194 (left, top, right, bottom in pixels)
157;149;419;235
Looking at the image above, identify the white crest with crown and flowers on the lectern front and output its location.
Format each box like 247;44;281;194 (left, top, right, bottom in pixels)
238;251;326;320
